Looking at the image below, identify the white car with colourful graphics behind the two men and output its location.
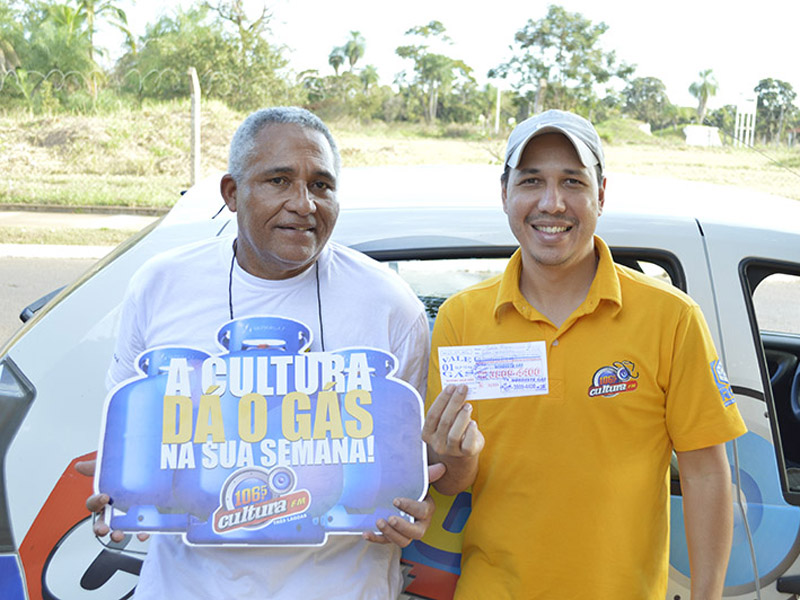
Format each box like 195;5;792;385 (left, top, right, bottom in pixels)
0;166;800;600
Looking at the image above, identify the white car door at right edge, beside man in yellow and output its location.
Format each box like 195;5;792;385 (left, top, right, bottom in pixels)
703;215;800;599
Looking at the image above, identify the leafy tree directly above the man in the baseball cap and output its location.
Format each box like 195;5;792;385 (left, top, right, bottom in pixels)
489;5;634;116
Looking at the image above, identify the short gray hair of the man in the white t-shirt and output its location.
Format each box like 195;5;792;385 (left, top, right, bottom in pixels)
228;106;342;181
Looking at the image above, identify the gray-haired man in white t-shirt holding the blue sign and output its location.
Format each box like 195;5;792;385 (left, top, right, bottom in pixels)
84;107;443;600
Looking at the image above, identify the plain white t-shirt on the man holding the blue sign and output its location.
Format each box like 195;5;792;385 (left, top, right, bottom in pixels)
107;237;429;600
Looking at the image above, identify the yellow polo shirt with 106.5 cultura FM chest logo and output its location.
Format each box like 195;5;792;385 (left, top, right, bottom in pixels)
428;237;745;600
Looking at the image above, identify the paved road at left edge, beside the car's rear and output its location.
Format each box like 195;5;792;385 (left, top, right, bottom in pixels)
0;257;97;345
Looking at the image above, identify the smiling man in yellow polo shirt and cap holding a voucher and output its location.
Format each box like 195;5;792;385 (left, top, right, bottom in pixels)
423;111;745;600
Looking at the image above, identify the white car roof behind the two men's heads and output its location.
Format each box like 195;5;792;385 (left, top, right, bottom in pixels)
164;165;800;251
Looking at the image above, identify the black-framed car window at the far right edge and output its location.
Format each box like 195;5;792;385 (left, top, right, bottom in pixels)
744;261;800;505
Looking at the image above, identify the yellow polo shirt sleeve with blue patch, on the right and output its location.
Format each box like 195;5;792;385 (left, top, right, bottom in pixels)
666;304;747;452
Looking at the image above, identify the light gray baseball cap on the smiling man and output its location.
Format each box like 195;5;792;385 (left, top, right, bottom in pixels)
506;110;606;175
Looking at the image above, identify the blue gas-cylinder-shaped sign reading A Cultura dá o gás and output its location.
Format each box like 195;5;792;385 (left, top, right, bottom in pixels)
95;316;428;545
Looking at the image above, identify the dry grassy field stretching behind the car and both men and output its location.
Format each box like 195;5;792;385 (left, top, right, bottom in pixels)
0;106;800;220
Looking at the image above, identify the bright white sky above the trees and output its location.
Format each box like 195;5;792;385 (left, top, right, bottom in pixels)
101;0;800;108
